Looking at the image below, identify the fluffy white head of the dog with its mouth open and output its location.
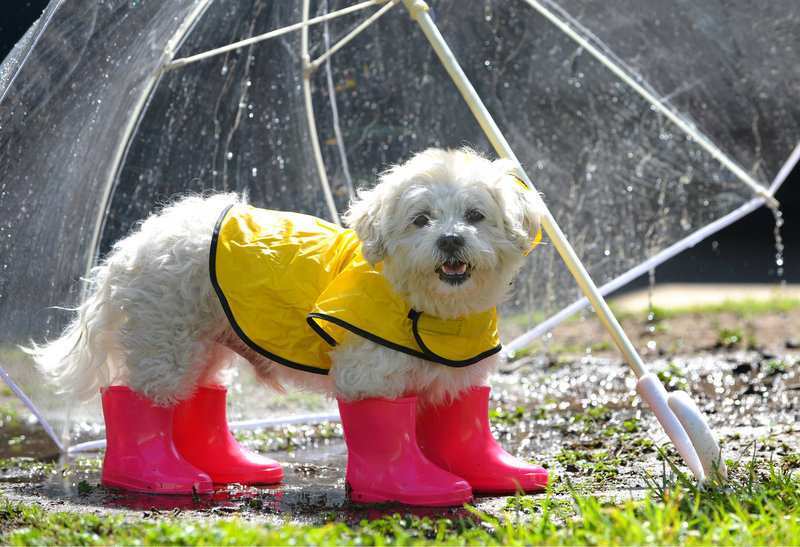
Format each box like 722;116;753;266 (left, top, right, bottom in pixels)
345;148;543;318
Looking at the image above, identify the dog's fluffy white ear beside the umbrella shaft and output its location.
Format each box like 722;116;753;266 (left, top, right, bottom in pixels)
500;175;545;254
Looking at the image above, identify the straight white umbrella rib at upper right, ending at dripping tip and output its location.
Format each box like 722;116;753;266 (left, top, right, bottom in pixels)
525;0;780;209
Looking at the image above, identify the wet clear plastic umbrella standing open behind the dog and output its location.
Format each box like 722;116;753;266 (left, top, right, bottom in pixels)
0;0;800;480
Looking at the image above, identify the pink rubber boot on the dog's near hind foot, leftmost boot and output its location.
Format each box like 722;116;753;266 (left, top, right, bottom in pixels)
101;386;214;494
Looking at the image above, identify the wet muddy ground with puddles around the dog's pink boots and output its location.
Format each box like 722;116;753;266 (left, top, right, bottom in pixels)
0;304;800;523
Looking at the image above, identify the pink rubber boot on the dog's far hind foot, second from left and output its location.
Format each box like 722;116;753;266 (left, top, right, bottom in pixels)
172;386;283;484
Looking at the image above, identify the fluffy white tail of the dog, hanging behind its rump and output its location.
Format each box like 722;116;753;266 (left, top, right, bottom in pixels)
22;264;124;399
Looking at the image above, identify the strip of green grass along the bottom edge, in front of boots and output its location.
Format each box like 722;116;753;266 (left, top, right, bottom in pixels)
0;458;800;545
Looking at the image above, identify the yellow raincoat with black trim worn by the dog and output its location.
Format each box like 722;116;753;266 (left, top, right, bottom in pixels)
210;205;501;374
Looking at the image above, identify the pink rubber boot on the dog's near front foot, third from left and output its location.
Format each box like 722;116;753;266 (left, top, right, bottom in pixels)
339;397;472;506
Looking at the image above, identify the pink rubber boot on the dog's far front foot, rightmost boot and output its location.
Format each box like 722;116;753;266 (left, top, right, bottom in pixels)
417;386;547;494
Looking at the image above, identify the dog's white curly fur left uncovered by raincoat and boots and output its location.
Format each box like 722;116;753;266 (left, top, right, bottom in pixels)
27;149;541;405
